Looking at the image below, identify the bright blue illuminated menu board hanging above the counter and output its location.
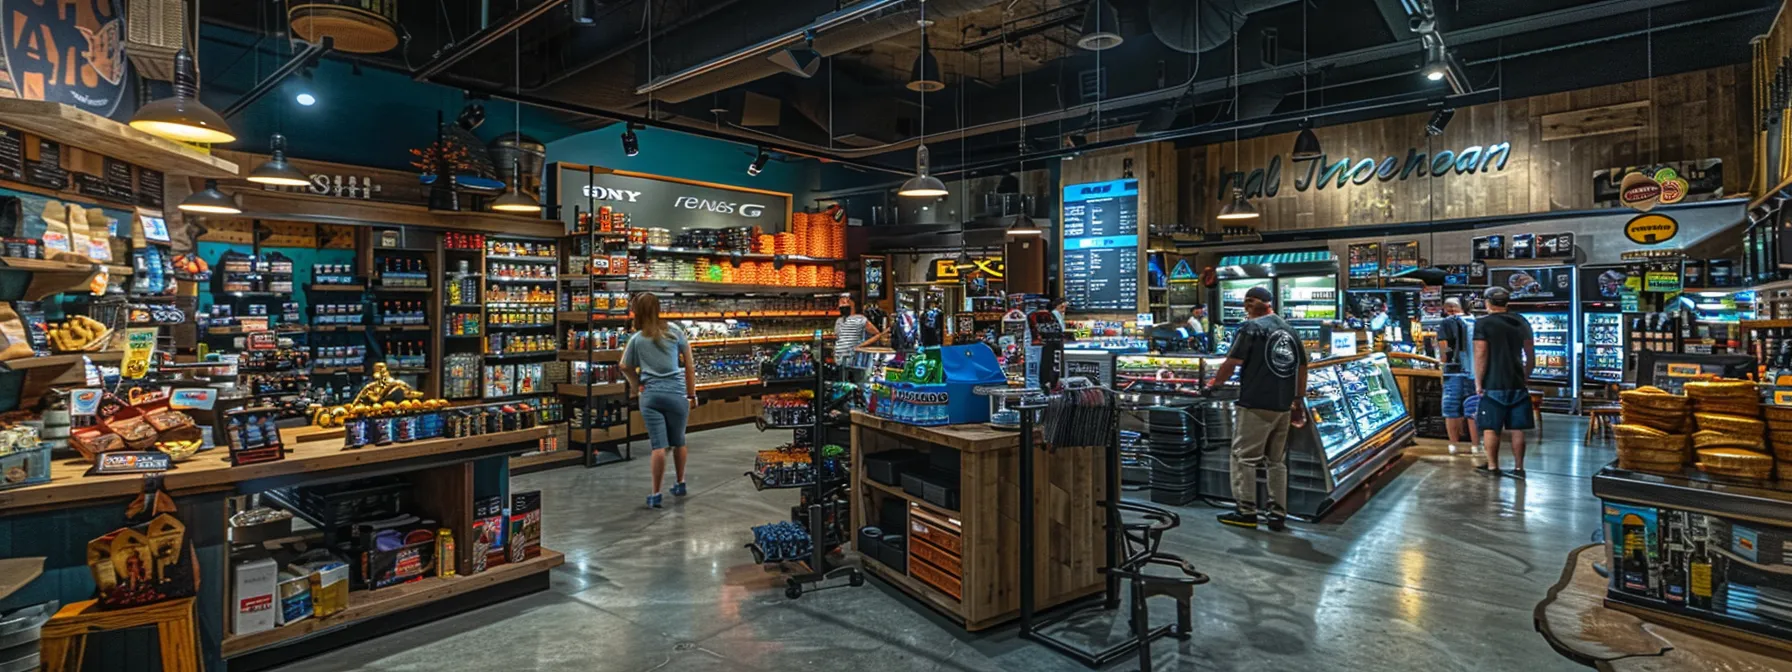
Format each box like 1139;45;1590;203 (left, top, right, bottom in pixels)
1061;179;1138;314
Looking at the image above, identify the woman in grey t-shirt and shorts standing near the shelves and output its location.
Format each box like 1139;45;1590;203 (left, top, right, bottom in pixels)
622;292;697;509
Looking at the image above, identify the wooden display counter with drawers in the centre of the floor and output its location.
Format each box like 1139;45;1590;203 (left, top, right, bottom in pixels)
853;412;1107;631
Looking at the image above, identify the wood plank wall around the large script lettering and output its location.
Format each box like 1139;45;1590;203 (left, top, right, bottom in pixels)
1182;65;1754;231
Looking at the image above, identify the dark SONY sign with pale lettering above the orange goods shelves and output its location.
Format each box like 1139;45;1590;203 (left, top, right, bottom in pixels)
548;163;790;233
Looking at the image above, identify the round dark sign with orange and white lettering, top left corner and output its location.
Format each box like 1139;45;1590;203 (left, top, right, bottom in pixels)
0;0;129;116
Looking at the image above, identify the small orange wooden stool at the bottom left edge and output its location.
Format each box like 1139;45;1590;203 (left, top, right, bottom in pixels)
43;597;199;672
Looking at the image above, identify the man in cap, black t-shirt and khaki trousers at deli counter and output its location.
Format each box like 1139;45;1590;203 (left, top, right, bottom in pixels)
1210;287;1306;532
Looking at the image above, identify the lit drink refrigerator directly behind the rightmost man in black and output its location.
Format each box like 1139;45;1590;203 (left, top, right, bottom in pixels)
1489;265;1581;412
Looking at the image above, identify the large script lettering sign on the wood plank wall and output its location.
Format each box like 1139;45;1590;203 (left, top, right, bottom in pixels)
1213;142;1512;201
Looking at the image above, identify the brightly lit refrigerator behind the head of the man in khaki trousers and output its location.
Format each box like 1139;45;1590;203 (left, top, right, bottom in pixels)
1213;249;1339;358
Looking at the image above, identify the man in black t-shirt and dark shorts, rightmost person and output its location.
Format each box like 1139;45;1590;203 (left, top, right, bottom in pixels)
1475;287;1538;478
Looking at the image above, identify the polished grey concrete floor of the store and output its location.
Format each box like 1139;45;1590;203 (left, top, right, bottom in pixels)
272;416;1613;672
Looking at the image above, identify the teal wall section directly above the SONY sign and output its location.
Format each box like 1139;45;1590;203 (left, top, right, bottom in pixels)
548;124;819;208
